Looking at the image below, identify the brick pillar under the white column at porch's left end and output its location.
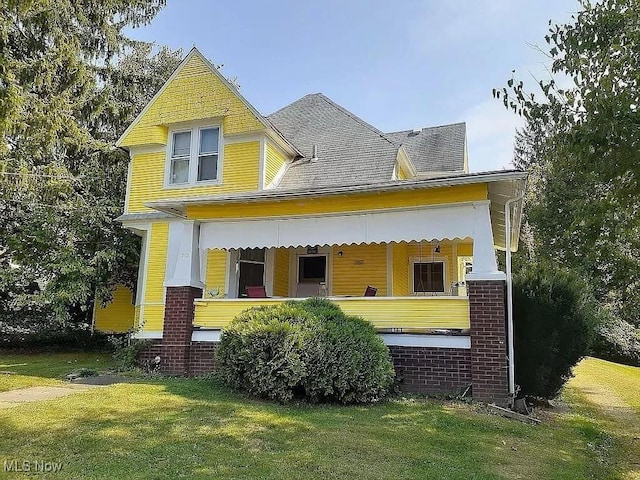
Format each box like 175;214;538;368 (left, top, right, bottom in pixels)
160;287;202;375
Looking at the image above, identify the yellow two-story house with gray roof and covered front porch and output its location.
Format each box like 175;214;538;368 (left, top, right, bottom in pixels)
112;49;525;401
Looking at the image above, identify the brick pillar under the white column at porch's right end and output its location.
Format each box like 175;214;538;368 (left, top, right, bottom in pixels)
467;279;509;406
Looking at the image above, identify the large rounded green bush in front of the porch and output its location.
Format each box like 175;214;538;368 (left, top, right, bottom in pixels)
216;299;394;403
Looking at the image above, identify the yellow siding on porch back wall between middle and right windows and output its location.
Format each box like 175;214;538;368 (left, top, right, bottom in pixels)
331;244;387;297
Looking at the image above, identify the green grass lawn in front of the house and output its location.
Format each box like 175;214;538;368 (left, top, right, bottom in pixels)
0;353;640;480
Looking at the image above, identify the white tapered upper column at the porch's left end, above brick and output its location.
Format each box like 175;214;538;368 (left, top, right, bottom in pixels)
164;220;203;288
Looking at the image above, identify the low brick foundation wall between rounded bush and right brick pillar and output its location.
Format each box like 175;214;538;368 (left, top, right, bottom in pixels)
389;345;471;394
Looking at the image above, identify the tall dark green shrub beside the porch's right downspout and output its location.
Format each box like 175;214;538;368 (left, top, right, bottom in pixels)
513;263;600;398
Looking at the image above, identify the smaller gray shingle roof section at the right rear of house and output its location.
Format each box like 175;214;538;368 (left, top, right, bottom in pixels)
387;123;467;173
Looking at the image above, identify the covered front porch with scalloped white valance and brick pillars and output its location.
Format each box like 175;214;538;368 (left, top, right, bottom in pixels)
138;174;522;402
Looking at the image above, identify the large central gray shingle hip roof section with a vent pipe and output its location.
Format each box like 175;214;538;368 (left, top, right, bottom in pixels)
267;93;398;188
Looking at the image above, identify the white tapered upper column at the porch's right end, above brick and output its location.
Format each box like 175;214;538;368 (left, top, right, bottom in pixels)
467;202;506;280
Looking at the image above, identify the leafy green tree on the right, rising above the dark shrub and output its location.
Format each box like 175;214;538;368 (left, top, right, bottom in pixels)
494;0;640;344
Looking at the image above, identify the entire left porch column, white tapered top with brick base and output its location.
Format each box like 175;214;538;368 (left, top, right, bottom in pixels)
160;221;203;375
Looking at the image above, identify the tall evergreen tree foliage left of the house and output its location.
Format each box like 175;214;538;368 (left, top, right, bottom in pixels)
0;0;180;319
